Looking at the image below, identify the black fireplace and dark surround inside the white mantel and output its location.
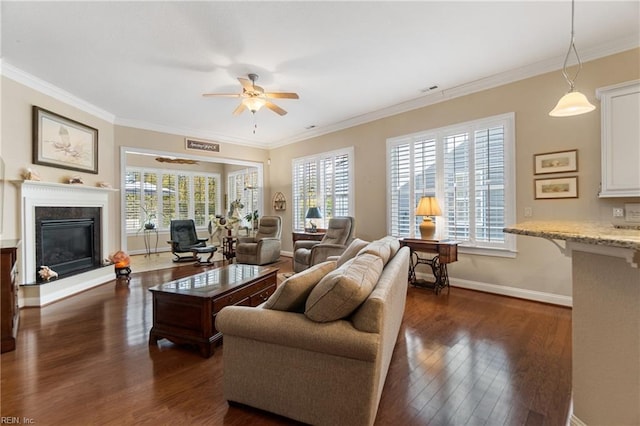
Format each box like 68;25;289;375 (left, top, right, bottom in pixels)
35;207;102;282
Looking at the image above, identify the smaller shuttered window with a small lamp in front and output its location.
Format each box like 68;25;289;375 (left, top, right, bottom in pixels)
292;148;353;230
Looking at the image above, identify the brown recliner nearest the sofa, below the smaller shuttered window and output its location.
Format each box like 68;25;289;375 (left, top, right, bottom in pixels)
293;216;354;272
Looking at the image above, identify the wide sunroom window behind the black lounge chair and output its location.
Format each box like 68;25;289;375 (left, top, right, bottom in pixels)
125;167;221;232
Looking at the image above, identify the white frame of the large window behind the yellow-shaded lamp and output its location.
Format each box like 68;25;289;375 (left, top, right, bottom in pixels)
386;112;516;257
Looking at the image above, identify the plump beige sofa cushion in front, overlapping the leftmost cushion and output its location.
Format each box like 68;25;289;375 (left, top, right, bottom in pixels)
304;253;383;322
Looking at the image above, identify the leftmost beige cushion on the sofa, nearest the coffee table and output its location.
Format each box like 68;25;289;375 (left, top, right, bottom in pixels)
263;262;336;312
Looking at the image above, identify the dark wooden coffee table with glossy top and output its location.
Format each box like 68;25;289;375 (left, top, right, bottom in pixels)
149;264;278;358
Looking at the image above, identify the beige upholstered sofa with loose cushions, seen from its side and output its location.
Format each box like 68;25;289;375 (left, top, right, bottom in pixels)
216;237;409;426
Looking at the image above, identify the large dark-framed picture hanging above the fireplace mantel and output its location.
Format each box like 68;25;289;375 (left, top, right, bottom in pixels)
33;105;98;174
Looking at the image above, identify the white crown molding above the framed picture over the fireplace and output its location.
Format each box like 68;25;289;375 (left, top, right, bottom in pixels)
0;59;116;124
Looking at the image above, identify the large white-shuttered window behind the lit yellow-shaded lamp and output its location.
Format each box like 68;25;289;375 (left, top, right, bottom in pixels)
387;114;515;253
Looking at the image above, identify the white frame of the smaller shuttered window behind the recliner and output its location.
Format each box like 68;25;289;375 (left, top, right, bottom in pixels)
291;146;355;232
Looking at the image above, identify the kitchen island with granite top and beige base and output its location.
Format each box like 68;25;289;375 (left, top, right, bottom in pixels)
504;221;640;425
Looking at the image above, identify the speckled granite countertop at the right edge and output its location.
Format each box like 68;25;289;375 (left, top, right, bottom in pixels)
504;221;640;250
